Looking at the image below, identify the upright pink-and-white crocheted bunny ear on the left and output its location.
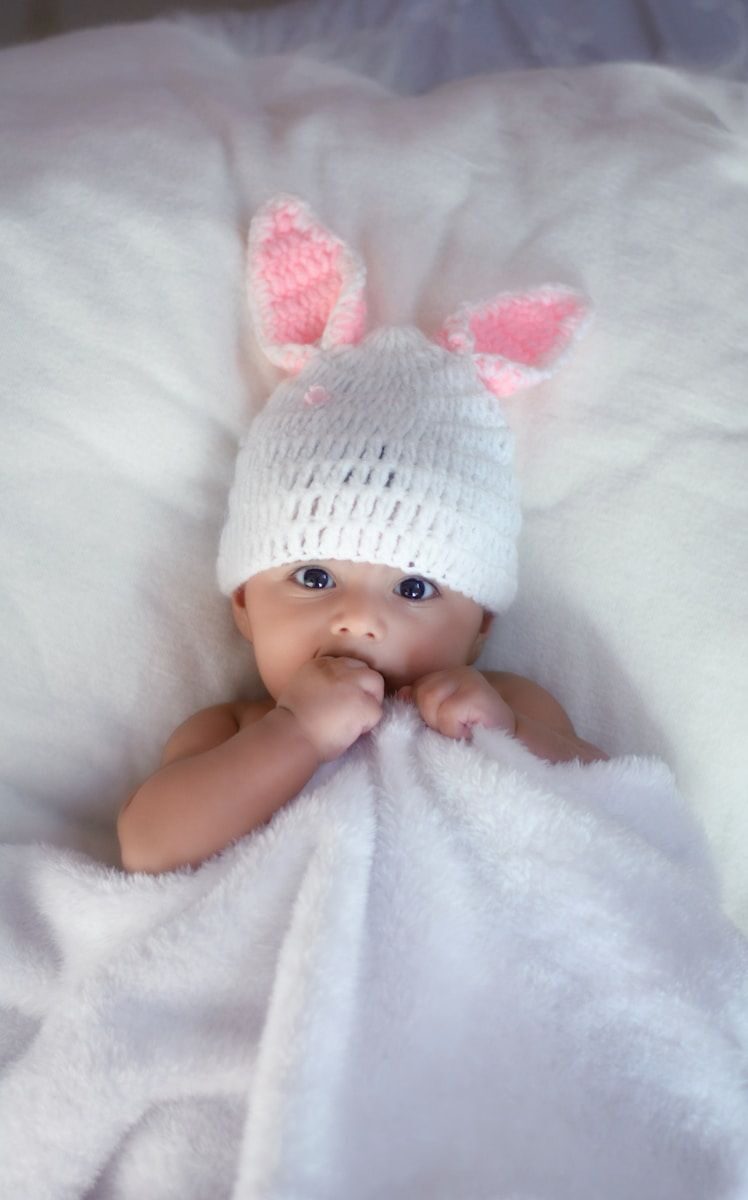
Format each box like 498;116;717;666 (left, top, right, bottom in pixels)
247;194;366;374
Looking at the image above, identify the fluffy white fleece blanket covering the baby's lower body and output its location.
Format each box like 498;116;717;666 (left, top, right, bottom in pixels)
0;702;748;1200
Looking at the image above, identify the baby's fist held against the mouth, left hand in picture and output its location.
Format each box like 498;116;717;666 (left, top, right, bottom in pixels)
277;655;384;762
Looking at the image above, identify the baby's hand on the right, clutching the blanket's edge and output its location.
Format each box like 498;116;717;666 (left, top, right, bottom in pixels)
397;666;516;738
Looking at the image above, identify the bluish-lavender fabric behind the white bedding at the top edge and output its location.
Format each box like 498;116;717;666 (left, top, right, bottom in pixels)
188;0;748;95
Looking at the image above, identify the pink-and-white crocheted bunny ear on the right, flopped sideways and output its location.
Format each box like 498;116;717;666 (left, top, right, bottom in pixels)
436;284;590;396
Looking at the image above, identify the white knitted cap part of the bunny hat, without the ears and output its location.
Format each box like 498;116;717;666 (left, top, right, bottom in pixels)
219;328;520;612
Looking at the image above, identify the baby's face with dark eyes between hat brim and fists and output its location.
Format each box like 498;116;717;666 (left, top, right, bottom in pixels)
232;559;492;700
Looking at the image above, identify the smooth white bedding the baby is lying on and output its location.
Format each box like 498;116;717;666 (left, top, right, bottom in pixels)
0;20;748;926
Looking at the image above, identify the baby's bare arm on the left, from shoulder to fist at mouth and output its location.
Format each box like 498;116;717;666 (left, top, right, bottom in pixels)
116;658;384;874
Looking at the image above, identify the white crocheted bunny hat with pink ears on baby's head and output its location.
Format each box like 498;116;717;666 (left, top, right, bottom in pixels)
217;196;587;612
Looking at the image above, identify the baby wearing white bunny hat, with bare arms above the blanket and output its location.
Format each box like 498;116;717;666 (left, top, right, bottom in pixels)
118;196;606;874
